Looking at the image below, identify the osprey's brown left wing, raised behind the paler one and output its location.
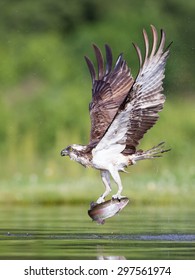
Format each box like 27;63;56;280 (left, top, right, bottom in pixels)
85;45;134;148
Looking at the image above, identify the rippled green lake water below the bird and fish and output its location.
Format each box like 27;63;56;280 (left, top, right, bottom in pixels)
0;204;195;260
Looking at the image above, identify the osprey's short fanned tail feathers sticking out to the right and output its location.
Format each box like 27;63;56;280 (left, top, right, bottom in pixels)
130;142;171;164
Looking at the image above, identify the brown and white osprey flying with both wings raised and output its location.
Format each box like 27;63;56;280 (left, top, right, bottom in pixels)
61;25;170;203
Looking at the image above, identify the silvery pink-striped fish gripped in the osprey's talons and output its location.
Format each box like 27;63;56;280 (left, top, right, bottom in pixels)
88;197;129;224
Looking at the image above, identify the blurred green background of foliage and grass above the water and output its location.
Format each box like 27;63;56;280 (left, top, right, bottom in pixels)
0;0;195;204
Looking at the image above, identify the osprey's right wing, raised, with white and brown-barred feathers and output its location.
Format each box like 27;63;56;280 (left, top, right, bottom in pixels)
93;25;169;154
